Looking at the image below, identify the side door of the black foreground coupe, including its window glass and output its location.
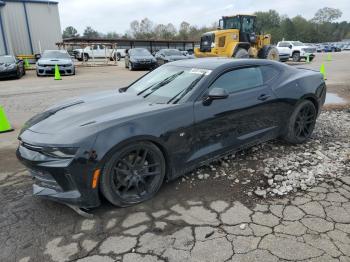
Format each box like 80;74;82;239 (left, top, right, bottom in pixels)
188;67;279;164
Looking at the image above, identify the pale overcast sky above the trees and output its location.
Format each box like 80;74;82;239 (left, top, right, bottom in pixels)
57;0;350;34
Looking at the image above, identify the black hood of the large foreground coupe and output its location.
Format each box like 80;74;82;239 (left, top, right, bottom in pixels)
22;90;170;136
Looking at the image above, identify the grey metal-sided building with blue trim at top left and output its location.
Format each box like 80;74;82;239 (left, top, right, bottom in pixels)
0;0;62;55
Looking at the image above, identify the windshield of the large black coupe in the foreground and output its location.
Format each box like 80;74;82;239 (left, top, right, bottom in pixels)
126;66;211;104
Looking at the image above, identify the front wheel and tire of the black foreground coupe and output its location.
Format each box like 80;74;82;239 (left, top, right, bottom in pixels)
100;142;166;207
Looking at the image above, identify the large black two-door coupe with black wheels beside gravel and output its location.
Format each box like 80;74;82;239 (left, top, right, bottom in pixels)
17;58;326;208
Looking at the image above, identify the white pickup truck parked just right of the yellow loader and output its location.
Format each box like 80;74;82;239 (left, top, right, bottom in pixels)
276;41;316;62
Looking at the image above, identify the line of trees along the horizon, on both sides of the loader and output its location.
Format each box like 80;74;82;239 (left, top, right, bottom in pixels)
62;7;350;43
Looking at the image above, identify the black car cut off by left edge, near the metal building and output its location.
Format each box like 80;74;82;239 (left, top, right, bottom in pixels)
0;55;26;78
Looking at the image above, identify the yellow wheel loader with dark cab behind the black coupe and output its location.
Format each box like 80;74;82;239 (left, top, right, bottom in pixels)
194;15;279;61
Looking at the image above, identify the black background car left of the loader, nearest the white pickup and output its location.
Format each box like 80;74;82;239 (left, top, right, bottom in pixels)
125;48;157;71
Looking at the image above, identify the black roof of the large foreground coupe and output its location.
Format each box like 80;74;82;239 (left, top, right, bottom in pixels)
168;57;279;70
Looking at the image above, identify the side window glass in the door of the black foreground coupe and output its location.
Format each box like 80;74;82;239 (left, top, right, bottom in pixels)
211;67;263;93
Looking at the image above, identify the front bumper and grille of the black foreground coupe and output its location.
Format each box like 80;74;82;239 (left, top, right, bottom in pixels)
16;143;100;208
